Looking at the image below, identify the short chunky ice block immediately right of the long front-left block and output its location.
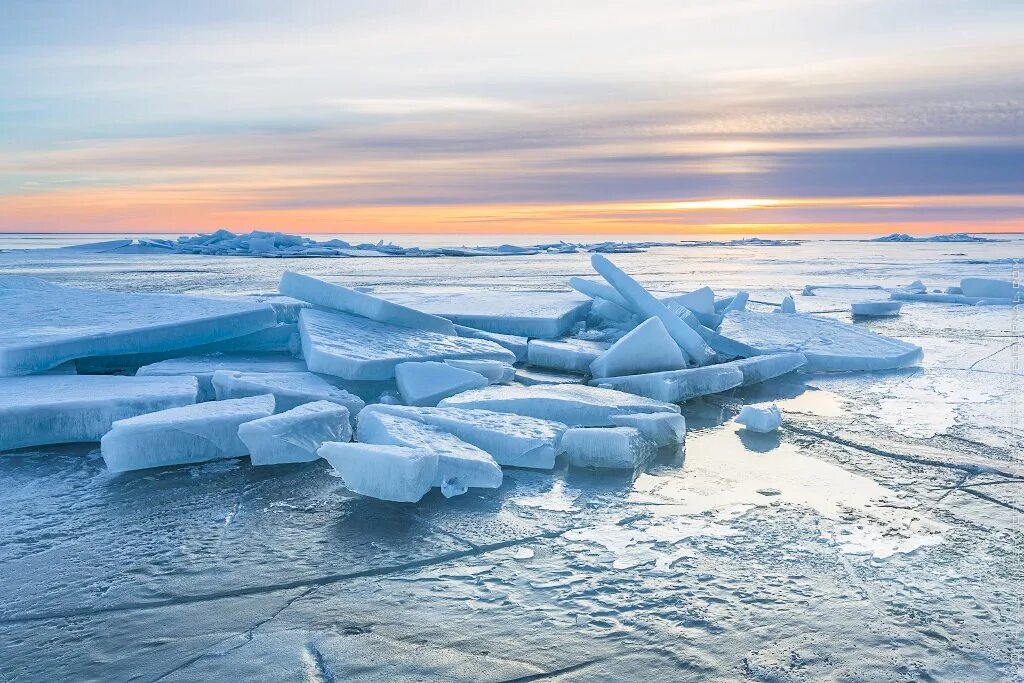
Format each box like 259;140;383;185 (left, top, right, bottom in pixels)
239;400;352;465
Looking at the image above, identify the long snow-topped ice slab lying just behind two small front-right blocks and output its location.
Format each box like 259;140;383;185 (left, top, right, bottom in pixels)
439;385;679;427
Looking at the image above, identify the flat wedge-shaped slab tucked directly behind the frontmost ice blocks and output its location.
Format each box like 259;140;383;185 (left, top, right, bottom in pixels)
365;404;568;470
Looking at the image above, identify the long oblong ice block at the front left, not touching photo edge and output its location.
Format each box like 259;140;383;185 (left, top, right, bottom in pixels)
99;393;273;472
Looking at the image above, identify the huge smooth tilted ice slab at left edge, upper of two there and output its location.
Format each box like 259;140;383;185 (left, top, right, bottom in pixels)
0;276;278;376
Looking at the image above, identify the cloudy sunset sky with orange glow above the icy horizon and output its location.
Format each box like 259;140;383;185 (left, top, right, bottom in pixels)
0;0;1024;236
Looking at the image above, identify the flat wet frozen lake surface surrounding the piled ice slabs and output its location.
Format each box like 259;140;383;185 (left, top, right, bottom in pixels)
0;237;1024;681
